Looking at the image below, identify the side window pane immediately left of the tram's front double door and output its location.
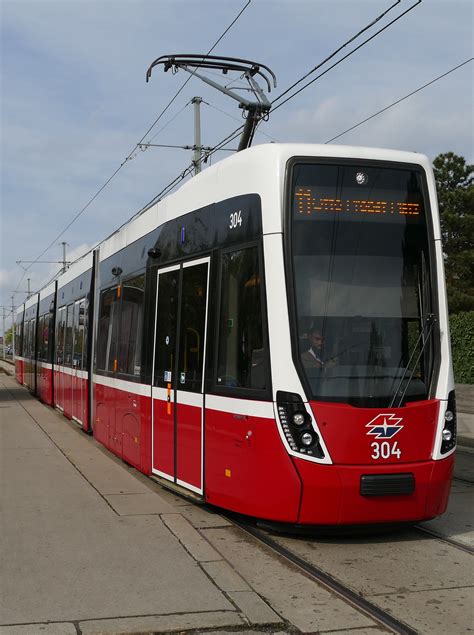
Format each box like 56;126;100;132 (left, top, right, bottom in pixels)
118;275;145;376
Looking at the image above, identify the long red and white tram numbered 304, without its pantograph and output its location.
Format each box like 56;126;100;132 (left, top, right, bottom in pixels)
15;144;456;527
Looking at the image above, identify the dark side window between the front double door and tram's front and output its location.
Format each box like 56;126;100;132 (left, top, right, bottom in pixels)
217;247;268;390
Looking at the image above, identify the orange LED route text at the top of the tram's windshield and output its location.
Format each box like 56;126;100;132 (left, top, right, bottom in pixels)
295;187;421;216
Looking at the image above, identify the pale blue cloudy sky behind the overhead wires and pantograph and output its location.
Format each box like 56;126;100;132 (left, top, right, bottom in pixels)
0;0;474;333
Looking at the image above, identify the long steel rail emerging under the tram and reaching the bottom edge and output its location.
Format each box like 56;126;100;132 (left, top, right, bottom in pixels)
228;514;418;635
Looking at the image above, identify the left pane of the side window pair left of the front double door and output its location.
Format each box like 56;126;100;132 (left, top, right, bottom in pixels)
97;287;119;372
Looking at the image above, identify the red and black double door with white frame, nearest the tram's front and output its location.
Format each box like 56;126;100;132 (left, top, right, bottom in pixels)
152;258;209;494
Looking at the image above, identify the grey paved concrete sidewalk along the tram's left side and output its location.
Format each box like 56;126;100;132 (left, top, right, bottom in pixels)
0;375;285;635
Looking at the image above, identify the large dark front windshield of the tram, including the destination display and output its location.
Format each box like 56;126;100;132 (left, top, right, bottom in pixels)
290;163;434;407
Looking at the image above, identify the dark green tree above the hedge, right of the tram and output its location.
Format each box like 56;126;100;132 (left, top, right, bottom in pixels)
433;152;474;314
